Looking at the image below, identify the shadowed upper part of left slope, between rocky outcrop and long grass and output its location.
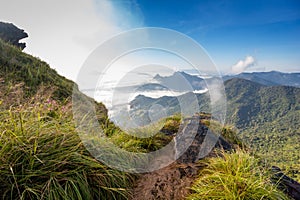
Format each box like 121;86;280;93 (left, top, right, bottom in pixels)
0;39;107;118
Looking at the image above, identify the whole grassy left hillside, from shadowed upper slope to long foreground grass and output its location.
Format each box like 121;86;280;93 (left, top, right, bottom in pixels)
0;37;133;199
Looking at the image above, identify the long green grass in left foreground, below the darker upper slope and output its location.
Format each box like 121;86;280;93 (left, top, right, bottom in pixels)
0;92;133;200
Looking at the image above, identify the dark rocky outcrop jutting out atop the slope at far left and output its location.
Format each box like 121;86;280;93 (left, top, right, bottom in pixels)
0;22;28;50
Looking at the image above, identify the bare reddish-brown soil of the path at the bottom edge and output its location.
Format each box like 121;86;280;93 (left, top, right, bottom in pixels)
132;163;201;200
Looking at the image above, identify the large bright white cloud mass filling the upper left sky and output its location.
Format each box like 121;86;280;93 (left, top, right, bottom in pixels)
0;0;143;80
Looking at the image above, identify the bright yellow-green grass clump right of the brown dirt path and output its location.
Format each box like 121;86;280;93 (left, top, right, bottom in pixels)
187;150;288;200
